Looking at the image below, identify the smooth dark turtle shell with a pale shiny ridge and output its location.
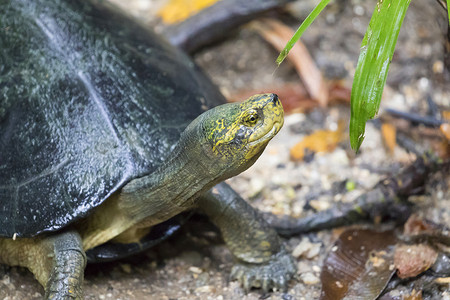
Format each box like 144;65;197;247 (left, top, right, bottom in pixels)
0;0;224;237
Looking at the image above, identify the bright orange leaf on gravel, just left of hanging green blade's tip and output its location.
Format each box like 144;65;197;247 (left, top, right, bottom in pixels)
290;122;344;160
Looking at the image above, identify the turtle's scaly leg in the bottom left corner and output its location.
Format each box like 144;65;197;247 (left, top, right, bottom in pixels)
0;231;86;300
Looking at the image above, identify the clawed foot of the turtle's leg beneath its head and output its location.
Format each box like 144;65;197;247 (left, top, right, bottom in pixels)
230;250;296;292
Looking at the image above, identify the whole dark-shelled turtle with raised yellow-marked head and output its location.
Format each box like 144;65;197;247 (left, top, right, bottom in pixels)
0;0;296;299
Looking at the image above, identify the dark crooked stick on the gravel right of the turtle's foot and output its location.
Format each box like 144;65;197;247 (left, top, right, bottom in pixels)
266;156;449;236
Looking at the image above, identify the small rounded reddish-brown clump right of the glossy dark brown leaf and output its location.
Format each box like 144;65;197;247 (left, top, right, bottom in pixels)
394;244;438;278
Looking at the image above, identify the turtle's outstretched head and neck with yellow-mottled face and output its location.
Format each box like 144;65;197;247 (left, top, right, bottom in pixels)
79;94;283;249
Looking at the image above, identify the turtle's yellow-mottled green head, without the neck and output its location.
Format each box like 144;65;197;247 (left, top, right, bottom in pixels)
192;94;283;179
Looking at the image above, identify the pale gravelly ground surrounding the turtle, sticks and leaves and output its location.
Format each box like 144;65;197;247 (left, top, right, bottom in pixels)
0;0;450;299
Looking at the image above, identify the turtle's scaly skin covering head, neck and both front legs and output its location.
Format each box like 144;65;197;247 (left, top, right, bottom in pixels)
0;94;295;299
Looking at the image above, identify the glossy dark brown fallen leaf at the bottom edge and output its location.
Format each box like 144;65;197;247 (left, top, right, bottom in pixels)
320;229;395;300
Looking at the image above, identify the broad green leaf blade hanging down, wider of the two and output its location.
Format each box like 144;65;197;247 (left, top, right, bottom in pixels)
350;0;414;151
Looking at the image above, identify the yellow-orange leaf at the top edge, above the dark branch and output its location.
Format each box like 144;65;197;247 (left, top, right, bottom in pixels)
157;0;218;24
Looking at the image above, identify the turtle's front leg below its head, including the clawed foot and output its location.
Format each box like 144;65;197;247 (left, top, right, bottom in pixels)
198;183;296;291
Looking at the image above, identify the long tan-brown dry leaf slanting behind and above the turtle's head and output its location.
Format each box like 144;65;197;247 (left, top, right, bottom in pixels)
250;19;328;107
